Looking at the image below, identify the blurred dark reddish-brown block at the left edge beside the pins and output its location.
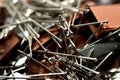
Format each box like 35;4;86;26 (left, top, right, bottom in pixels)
0;33;20;60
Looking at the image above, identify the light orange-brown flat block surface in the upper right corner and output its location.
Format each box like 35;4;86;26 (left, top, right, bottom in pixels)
90;4;120;29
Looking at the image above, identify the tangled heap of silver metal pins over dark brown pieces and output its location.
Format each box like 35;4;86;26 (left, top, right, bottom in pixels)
0;0;120;80
